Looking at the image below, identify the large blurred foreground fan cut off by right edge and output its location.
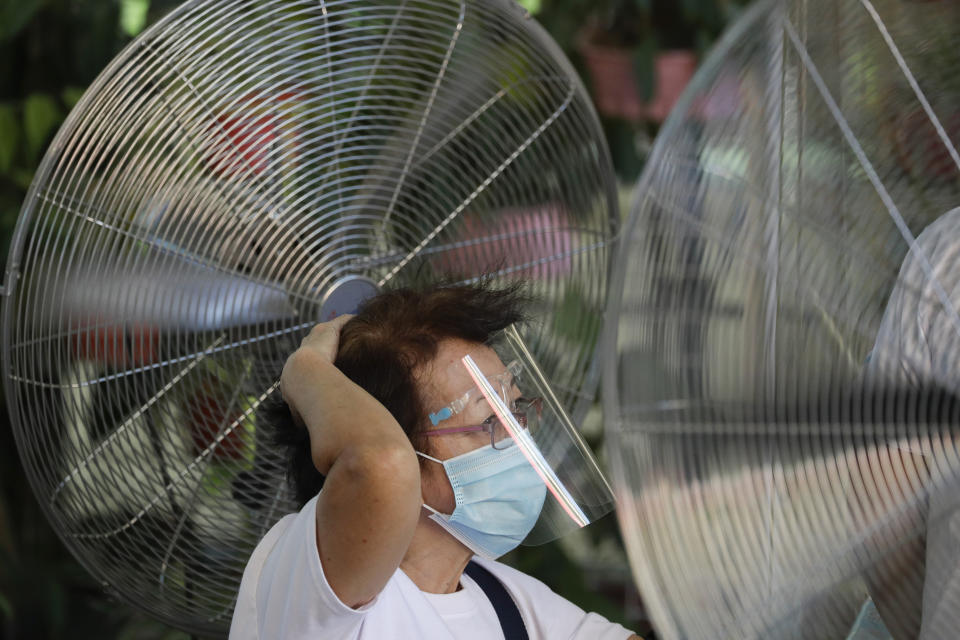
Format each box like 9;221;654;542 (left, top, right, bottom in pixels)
604;0;960;639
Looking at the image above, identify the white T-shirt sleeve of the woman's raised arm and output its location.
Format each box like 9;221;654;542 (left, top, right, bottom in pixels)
230;497;377;640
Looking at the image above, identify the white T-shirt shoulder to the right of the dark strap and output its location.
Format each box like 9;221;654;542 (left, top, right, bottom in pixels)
474;558;633;640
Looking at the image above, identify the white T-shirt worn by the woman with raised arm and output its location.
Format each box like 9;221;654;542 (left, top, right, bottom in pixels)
230;497;631;640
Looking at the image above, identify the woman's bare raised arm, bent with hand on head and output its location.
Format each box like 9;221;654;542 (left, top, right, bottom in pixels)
280;338;420;607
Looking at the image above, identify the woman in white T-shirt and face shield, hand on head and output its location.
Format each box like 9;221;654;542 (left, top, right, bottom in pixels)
230;284;637;640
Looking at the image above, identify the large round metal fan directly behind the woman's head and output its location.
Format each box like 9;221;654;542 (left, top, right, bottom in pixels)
3;0;618;635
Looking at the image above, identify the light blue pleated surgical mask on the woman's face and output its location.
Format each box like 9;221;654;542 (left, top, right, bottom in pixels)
417;445;547;560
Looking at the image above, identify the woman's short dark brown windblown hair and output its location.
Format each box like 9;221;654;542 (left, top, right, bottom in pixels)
261;281;527;505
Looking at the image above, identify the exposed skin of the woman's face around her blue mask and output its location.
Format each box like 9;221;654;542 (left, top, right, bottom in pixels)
418;340;519;513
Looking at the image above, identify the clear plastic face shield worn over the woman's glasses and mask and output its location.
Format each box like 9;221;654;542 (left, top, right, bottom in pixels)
425;327;614;545
